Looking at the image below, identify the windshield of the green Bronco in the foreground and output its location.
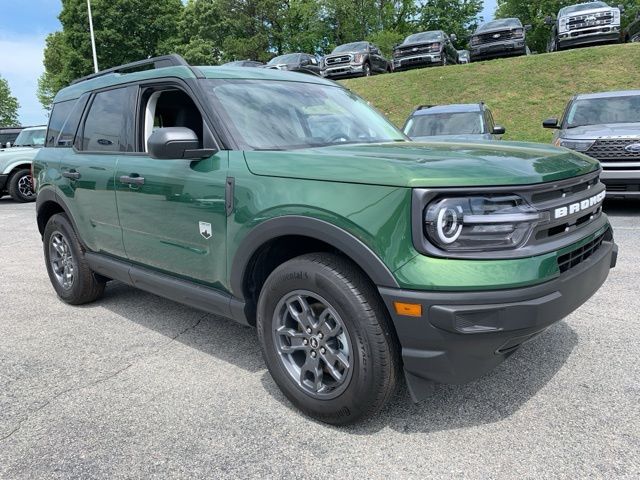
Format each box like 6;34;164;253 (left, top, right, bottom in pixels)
207;80;406;150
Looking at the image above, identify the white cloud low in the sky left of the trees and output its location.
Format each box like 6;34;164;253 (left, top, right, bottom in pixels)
0;34;47;125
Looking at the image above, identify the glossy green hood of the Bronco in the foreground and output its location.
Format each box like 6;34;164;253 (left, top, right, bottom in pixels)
245;141;599;187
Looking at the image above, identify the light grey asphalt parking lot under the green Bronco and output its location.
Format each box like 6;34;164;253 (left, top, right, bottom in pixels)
0;198;640;479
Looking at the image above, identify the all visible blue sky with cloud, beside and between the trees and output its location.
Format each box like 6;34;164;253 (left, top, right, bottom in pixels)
0;0;496;125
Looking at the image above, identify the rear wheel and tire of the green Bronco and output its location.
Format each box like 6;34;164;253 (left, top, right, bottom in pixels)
43;213;106;305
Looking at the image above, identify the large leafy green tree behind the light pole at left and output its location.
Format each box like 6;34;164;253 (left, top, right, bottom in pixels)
38;0;183;108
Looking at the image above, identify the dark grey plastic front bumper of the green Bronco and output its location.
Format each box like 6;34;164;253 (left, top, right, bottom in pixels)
379;229;617;401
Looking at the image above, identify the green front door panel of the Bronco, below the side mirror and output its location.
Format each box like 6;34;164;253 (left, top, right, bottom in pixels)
115;152;228;288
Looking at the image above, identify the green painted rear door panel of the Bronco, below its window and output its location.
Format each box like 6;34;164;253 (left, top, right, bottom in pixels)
58;148;125;257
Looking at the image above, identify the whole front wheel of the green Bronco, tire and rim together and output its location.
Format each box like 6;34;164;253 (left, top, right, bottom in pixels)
257;253;399;425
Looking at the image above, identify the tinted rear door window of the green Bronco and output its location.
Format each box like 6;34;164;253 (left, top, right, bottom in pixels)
82;87;135;152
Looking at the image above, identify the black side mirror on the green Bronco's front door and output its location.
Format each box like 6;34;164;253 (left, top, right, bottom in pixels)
147;127;215;160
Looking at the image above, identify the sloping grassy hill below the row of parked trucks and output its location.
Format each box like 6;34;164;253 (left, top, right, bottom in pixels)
344;43;640;142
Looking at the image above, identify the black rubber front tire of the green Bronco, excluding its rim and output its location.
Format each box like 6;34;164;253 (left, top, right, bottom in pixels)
257;257;392;424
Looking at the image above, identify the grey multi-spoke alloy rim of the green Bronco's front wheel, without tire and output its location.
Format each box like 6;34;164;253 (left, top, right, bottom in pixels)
273;290;353;399
